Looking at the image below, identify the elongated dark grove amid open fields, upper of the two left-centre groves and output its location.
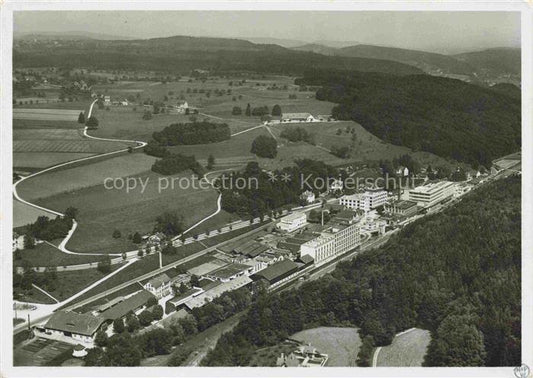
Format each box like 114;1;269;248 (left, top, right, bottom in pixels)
152;121;231;146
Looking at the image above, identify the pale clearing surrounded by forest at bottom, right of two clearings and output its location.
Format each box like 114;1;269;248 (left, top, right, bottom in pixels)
377;328;431;367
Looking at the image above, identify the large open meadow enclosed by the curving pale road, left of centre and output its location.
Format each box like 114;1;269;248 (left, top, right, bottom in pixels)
38;171;218;253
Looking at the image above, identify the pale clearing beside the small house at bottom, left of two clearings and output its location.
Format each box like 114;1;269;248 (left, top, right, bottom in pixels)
291;327;361;367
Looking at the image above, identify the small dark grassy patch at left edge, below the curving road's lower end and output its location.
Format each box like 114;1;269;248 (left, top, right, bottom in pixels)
13;243;106;266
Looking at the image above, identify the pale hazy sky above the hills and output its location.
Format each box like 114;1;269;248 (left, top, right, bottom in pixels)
14;11;520;54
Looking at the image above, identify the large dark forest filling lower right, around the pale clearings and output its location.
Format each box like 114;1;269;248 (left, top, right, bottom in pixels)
203;176;521;366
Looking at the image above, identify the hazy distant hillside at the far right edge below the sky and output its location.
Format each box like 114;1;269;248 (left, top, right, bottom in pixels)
454;48;521;75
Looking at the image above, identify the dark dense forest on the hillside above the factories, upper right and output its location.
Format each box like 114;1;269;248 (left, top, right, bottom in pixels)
295;70;521;168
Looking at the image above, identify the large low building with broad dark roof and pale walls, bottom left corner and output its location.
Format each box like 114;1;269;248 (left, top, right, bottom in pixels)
36;311;104;347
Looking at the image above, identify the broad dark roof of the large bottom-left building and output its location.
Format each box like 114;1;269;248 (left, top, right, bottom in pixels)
44;311;104;336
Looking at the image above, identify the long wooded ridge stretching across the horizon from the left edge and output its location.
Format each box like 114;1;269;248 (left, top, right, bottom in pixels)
13;36;423;75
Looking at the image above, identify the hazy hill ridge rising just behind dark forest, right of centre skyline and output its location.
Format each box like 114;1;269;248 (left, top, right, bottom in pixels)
338;45;474;75
